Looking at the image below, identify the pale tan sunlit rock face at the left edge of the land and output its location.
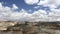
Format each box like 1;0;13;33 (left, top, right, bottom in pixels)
0;21;17;30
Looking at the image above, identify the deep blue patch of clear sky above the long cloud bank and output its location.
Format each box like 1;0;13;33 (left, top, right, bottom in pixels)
0;0;49;13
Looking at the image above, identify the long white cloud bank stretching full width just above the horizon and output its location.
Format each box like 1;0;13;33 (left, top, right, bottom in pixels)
0;3;60;21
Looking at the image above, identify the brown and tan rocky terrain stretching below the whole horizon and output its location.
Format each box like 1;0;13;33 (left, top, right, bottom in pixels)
0;21;60;34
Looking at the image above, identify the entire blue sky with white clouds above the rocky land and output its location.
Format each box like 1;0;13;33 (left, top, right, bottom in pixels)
0;0;60;21
